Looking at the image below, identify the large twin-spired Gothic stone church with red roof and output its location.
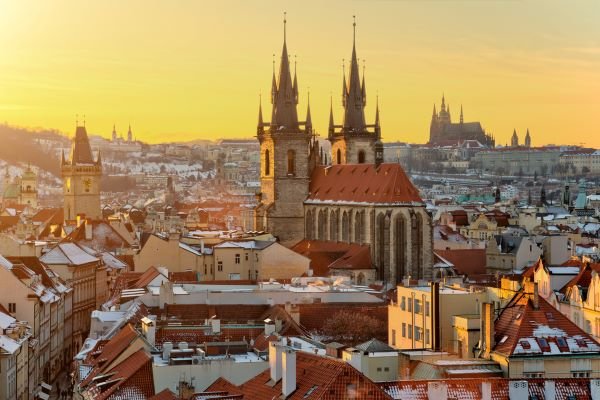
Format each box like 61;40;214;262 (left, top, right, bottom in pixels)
255;21;433;284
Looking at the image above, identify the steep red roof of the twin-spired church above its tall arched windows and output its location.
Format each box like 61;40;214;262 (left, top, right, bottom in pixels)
307;164;423;204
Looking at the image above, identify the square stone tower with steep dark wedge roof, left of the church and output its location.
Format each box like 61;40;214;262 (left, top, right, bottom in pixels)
61;125;102;220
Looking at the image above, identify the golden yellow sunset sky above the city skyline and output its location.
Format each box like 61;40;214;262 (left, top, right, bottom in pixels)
0;0;600;147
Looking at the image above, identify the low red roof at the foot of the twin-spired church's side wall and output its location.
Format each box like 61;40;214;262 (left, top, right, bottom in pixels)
292;240;373;276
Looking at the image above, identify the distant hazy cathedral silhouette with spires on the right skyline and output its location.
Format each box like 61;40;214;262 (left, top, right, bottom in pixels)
429;96;496;148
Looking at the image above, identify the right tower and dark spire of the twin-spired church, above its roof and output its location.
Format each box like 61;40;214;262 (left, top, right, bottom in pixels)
328;21;381;164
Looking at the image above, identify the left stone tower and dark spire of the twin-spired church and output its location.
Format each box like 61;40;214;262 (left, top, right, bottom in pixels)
255;18;319;245
